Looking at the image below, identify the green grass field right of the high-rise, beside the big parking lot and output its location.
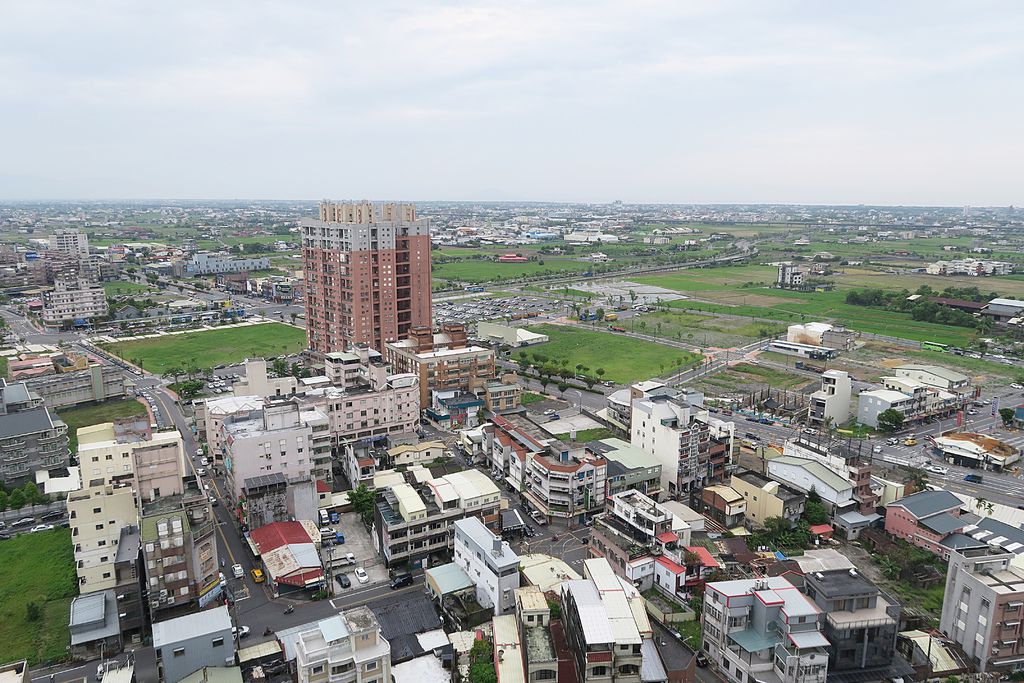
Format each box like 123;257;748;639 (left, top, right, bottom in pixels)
528;325;701;384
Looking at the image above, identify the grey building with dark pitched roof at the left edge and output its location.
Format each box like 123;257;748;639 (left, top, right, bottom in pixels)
0;378;70;485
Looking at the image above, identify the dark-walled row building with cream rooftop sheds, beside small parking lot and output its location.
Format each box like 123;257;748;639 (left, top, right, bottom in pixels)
371;469;501;567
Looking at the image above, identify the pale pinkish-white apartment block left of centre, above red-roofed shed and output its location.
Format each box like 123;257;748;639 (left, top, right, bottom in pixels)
221;399;331;502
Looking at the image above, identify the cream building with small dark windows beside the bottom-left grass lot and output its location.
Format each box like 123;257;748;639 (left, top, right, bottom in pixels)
68;484;138;593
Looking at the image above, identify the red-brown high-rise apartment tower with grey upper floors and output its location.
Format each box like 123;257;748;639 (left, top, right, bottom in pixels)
301;202;431;355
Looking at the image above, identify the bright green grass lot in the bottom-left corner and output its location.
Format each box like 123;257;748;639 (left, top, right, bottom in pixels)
0;528;78;665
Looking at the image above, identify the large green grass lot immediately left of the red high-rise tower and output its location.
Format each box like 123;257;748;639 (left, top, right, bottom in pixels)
102;323;306;375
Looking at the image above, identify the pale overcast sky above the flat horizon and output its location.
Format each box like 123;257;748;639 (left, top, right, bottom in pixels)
0;0;1024;206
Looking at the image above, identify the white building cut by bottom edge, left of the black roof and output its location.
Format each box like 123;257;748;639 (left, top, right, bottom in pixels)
295;606;391;683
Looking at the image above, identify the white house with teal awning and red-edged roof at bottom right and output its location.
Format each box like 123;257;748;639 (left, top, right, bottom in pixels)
701;577;829;683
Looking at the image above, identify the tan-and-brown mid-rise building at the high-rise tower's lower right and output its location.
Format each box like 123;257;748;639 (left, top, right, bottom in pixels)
384;323;496;410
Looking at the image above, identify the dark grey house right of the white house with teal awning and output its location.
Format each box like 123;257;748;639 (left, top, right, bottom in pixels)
804;569;912;680
